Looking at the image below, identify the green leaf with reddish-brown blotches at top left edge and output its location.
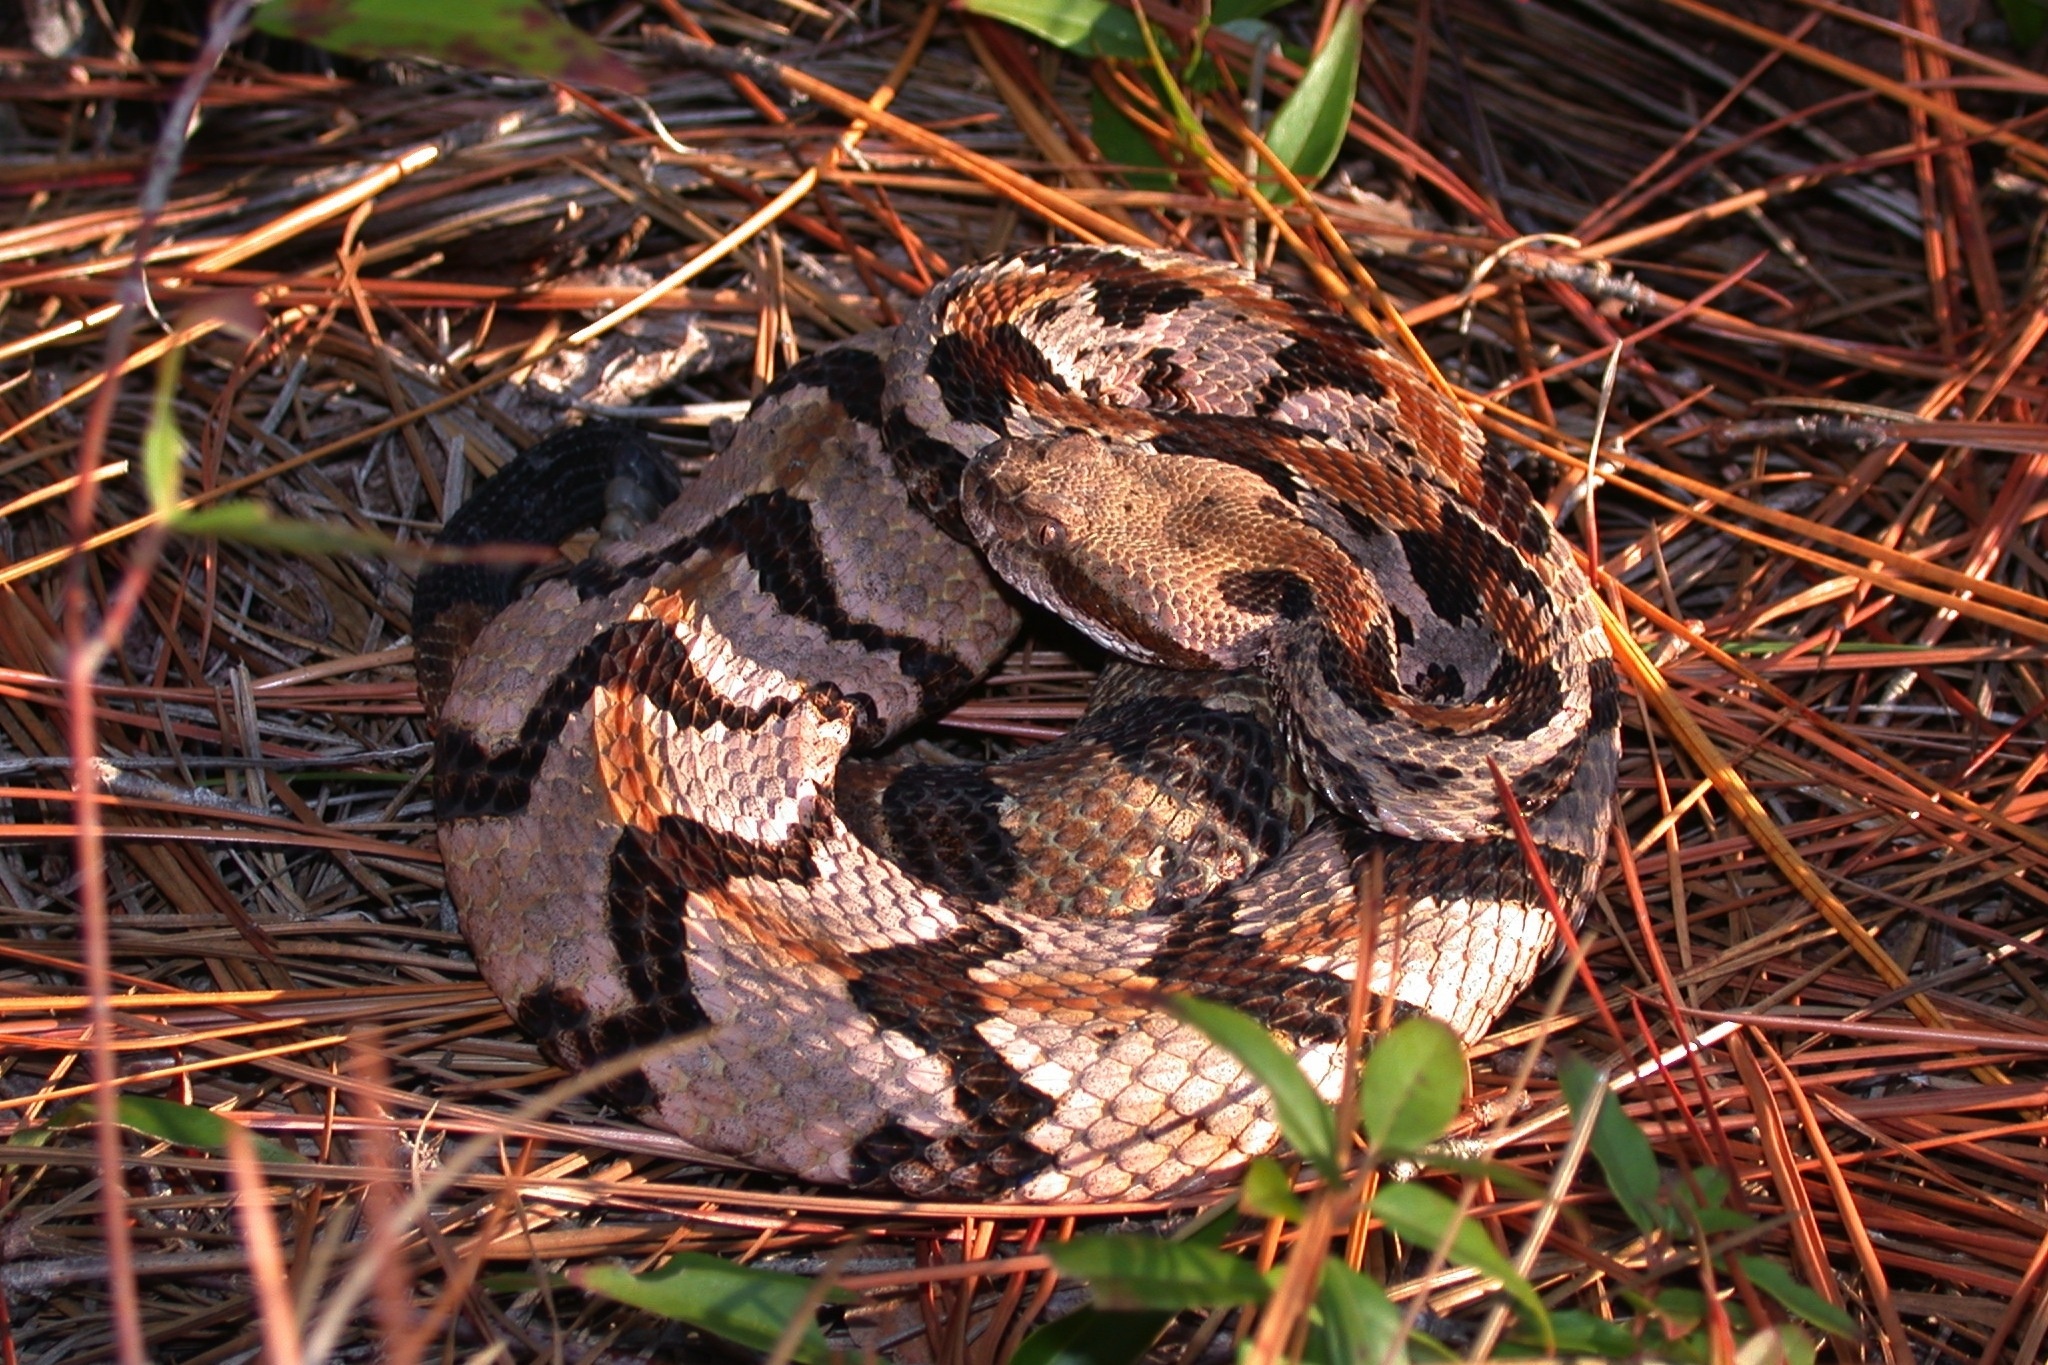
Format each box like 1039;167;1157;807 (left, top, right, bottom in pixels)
256;0;647;94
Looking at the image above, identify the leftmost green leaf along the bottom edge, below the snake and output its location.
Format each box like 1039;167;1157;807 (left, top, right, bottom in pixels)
569;1250;854;1365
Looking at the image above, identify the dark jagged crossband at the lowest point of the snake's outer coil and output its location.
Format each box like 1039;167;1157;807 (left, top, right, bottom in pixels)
846;913;1055;1197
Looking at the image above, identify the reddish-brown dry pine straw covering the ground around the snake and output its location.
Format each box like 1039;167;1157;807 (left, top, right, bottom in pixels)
0;0;2048;1363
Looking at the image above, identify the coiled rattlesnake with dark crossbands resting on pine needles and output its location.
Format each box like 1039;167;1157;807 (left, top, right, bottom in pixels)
414;248;1620;1201
